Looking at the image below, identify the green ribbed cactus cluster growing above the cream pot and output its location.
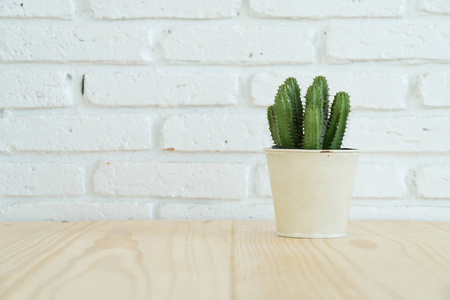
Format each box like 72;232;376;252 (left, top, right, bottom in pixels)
267;76;350;149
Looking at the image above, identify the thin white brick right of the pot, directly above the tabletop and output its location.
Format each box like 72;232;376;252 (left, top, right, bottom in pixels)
349;206;450;221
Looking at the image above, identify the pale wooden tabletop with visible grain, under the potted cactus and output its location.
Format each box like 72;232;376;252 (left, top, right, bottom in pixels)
0;220;450;300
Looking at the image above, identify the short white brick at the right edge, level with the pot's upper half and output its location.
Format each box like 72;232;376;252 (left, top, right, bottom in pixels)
416;164;450;199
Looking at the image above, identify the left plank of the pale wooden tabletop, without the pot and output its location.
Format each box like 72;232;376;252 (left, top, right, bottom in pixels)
0;221;231;300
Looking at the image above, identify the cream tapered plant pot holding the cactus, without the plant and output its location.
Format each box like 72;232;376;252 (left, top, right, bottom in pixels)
264;149;359;238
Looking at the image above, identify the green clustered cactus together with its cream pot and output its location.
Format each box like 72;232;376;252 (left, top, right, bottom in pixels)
264;76;359;238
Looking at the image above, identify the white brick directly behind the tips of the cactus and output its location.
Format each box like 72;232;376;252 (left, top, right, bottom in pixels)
251;72;408;110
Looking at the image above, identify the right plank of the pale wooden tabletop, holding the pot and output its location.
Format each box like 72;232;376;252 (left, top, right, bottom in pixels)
233;221;450;300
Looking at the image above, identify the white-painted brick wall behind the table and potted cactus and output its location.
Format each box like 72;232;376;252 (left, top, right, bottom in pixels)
0;0;450;221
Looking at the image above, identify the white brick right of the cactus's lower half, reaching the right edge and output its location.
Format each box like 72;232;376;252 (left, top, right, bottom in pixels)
344;115;450;152
